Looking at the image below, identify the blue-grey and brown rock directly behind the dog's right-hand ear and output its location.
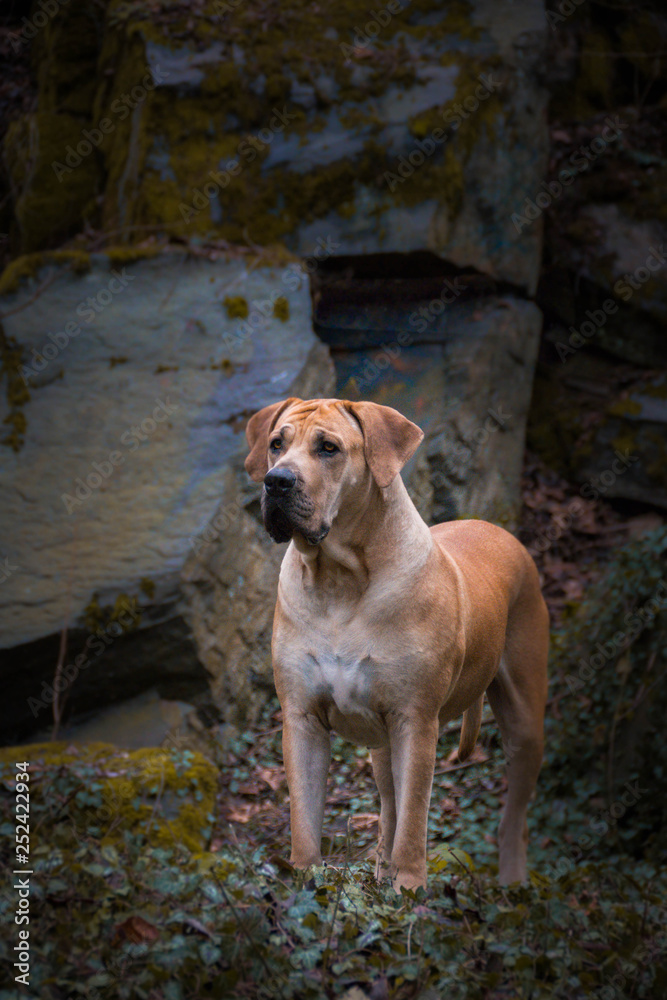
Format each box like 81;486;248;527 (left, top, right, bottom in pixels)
315;272;541;529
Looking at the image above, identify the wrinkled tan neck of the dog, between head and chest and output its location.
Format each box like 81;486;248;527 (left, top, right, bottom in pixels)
293;475;433;591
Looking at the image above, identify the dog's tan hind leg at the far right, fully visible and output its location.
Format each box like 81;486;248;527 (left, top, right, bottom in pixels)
487;588;549;884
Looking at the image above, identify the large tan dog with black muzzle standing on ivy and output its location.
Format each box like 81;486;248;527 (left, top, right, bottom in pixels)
245;398;549;890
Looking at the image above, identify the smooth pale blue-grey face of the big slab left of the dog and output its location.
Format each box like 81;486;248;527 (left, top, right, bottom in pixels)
0;253;331;647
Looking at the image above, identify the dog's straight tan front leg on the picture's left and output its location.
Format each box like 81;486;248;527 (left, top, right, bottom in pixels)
283;710;331;868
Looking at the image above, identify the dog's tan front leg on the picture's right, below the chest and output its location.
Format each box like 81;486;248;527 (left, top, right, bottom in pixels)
391;718;438;892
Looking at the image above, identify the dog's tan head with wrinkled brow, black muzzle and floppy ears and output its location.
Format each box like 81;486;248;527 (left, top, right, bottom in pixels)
245;397;424;545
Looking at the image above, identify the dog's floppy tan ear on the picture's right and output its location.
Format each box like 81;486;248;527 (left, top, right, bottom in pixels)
347;403;424;489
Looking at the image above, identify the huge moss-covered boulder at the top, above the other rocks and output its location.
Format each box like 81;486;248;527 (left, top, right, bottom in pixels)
3;0;548;294
